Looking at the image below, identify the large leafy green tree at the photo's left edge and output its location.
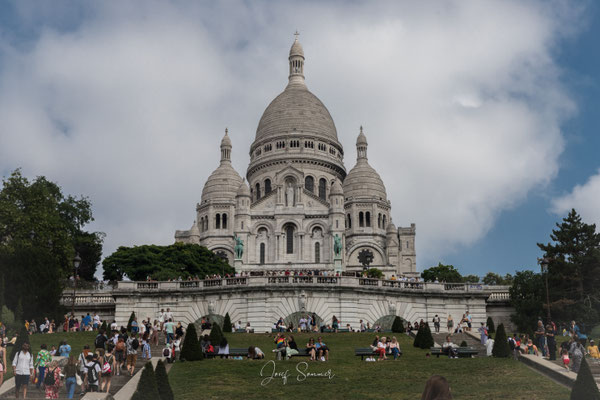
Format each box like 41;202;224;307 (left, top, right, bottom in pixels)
0;170;102;319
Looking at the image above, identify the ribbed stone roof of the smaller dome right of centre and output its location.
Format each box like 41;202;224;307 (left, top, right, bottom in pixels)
344;158;387;201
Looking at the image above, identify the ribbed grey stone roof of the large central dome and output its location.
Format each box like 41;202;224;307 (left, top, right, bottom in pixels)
255;85;338;142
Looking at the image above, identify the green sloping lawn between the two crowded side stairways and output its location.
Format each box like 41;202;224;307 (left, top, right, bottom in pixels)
169;333;569;400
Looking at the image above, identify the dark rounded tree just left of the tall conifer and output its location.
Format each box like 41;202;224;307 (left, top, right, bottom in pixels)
509;271;544;332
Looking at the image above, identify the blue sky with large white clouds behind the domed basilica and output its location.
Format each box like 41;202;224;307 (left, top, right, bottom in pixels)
0;0;600;275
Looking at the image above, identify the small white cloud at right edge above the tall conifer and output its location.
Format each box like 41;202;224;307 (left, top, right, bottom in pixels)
552;170;600;230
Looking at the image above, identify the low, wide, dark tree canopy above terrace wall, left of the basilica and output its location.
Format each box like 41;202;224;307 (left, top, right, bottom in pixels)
102;243;235;281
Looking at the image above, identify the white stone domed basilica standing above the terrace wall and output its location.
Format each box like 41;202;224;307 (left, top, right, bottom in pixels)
175;39;416;277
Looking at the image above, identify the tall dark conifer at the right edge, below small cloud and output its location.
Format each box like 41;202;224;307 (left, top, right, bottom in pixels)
538;209;600;325
